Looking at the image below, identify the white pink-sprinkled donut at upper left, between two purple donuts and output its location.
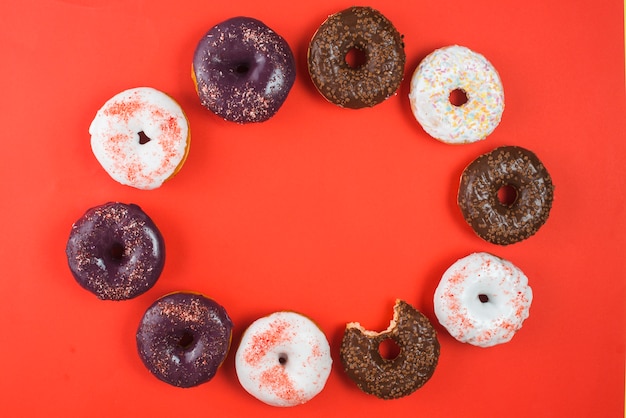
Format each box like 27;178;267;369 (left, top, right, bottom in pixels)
89;87;191;190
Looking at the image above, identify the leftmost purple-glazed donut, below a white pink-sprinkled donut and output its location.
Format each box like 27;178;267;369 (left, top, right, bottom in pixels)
65;202;165;300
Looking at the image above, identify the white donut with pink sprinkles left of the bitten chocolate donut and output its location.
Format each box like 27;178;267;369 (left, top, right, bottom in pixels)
235;312;332;407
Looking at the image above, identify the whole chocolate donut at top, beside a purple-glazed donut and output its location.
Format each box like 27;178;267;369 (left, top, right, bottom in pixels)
307;7;406;109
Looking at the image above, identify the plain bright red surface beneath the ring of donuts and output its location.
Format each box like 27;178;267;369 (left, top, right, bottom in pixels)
0;0;626;417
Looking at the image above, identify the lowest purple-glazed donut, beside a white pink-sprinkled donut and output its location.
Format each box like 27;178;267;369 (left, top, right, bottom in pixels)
136;292;233;388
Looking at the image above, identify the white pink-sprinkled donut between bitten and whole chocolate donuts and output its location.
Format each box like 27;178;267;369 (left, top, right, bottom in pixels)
434;253;533;347
